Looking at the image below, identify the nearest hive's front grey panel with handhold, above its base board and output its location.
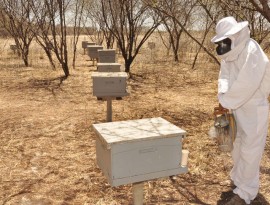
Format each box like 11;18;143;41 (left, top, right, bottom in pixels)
112;137;181;178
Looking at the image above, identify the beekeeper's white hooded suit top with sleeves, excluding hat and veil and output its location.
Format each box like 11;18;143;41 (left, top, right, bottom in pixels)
218;24;270;109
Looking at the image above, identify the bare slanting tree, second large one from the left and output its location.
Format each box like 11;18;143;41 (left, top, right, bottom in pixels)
31;0;71;79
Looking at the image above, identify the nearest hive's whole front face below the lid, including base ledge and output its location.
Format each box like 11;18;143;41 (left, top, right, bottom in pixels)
108;136;186;186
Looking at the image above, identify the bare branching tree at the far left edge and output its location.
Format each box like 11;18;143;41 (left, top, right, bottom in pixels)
0;0;34;66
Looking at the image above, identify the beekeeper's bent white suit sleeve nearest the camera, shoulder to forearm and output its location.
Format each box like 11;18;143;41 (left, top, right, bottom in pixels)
218;53;265;109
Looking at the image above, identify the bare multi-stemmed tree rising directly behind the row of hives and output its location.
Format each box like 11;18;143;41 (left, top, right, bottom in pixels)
101;0;160;72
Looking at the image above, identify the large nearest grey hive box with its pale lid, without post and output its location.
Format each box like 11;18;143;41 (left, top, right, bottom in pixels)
93;118;187;186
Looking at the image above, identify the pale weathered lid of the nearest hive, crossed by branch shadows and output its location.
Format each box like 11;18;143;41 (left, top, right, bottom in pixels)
93;117;186;149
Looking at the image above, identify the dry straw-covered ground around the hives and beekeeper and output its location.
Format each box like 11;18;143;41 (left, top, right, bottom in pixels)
0;37;270;205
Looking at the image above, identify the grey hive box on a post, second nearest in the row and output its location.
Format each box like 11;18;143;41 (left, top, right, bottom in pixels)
92;72;128;97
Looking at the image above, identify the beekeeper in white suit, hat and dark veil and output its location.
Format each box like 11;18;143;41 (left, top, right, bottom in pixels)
211;17;270;205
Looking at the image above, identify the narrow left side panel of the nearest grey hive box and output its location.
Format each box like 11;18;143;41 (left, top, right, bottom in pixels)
96;138;112;183
